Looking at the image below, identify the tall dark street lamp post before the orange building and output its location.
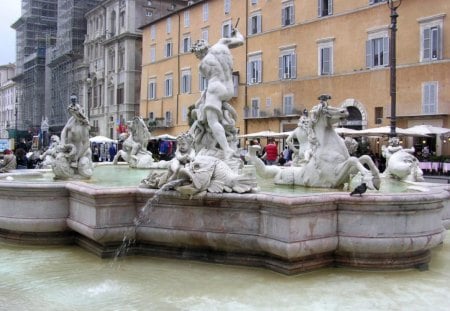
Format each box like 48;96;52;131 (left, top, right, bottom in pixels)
387;0;402;137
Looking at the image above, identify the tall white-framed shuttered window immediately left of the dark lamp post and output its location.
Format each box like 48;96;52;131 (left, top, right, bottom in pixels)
366;29;389;68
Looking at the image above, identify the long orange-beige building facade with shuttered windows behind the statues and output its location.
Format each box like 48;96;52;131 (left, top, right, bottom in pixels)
140;0;450;154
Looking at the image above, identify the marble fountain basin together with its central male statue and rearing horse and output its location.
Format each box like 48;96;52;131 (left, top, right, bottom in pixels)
0;26;450;274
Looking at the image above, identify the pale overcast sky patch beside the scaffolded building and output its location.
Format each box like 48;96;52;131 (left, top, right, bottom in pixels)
0;0;22;65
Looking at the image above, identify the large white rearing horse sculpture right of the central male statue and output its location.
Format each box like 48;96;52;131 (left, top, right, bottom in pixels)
248;97;380;189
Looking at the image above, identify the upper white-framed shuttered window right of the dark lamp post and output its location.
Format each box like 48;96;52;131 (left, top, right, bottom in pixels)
419;14;445;62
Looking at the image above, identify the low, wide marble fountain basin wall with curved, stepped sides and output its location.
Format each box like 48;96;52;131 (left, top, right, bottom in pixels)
0;166;450;274
